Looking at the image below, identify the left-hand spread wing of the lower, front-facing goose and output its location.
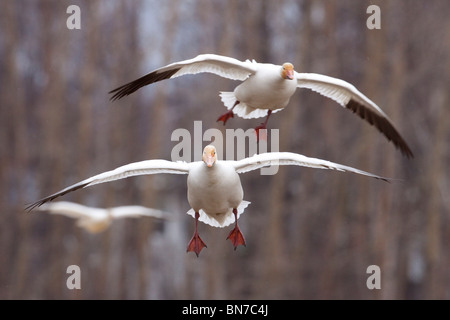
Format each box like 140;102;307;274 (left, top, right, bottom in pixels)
26;160;193;211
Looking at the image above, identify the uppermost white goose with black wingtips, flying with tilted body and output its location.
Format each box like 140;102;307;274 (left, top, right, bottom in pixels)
109;54;413;157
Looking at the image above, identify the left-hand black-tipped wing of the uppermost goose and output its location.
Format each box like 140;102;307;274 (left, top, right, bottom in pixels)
109;54;257;101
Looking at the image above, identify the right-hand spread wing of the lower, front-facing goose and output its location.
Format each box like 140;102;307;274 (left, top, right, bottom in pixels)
227;152;389;181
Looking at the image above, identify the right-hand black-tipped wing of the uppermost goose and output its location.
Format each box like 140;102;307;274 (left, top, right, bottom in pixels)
296;73;413;158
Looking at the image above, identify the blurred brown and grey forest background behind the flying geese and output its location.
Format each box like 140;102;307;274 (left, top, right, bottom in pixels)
0;0;450;299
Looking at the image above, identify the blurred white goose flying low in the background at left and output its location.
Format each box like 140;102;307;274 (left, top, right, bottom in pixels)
39;201;169;233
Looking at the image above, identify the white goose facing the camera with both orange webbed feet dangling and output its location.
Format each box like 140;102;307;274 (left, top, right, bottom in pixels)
26;145;388;256
